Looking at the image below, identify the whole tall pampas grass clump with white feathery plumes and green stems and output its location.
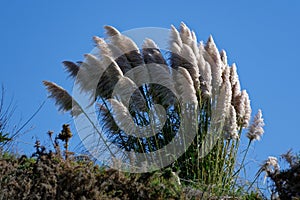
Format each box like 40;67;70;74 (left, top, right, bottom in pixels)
44;23;264;196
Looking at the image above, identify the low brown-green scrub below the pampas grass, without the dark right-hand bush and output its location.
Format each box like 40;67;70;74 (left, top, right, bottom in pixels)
0;138;261;200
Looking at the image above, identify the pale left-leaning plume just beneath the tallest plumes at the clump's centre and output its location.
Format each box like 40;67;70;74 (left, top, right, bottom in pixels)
174;67;198;105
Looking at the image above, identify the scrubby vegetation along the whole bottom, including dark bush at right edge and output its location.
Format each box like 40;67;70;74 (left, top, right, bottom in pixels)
0;132;300;200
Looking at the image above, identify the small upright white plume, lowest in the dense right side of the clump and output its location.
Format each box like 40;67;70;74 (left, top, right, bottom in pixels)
224;105;239;140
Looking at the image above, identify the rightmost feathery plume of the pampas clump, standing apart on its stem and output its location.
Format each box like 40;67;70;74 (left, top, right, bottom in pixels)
247;110;265;141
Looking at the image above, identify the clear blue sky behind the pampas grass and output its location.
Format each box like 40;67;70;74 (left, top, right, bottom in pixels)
0;0;300;188
